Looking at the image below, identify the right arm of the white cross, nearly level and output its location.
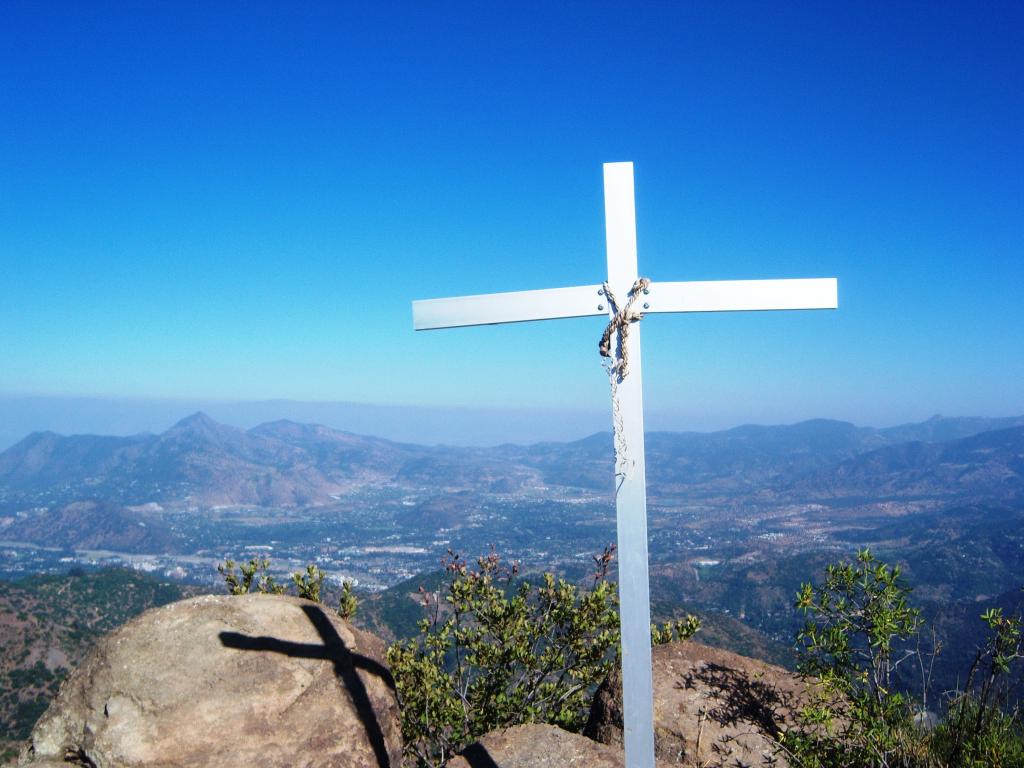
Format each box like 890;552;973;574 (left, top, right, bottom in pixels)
642;278;839;313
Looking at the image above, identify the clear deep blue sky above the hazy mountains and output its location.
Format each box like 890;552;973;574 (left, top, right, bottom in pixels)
0;1;1024;434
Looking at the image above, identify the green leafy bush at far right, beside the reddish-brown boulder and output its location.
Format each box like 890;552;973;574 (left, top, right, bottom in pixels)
780;549;1024;768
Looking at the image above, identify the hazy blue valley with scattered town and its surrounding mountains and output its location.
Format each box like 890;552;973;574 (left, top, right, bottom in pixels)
0;414;1024;757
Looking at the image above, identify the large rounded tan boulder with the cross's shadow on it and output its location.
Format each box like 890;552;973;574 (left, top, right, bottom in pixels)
19;595;401;768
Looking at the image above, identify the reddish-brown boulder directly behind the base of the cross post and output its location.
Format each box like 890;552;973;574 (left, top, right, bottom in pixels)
584;641;809;767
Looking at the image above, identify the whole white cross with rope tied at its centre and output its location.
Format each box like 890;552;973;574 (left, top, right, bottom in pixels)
413;163;839;768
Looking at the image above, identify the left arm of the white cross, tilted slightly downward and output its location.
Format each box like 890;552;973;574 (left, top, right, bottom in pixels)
413;286;608;331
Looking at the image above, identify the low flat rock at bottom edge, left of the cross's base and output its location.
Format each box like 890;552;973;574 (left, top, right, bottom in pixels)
447;725;668;768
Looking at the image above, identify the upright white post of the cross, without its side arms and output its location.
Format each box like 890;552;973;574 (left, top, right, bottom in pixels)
604;163;654;768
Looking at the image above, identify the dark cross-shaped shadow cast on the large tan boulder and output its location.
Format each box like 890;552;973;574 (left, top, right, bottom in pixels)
219;605;394;768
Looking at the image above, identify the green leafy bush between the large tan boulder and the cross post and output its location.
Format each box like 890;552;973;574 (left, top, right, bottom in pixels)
388;549;618;766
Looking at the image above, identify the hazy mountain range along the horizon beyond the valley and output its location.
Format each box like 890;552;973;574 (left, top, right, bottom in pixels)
0;413;1024;512
